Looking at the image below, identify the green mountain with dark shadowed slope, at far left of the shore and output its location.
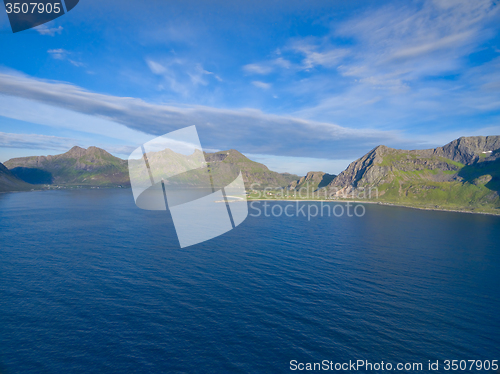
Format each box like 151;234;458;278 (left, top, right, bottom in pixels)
5;147;130;186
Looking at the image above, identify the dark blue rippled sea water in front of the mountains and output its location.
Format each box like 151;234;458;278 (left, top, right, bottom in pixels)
0;190;500;374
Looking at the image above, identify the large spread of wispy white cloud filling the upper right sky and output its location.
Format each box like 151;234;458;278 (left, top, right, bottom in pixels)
266;0;500;133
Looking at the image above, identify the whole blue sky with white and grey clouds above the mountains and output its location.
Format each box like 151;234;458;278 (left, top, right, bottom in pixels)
0;0;500;175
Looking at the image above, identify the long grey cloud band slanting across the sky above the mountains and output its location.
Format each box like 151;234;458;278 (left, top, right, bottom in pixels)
0;73;404;158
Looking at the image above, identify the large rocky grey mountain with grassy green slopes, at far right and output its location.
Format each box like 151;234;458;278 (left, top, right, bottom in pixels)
323;136;500;213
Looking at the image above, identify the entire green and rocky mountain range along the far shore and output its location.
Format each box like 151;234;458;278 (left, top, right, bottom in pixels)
0;136;500;213
